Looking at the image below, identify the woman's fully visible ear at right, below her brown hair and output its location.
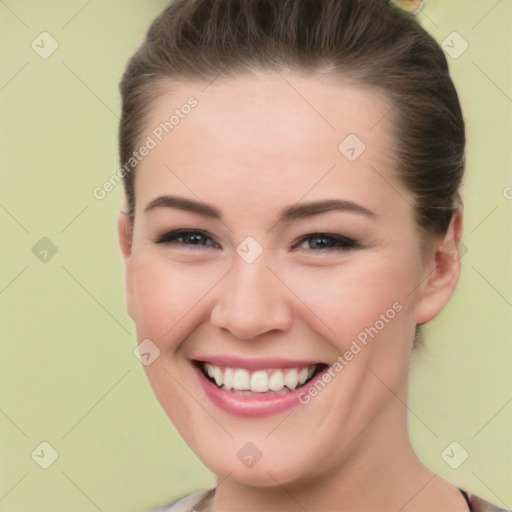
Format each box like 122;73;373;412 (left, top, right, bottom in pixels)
416;210;463;325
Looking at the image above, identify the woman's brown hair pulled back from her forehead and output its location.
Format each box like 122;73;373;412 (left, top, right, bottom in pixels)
119;0;465;235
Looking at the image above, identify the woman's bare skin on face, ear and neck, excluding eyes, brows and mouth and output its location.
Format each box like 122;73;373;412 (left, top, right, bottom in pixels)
119;73;467;511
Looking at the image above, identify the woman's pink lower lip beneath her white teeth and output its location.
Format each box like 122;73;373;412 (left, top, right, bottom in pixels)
194;365;318;418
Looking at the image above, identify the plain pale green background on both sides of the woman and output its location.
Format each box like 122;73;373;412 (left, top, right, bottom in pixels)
0;0;512;512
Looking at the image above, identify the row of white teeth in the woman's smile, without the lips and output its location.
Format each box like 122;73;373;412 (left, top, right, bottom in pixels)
203;363;316;393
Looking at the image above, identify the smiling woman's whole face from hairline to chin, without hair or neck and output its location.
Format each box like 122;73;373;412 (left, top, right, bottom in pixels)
120;73;444;485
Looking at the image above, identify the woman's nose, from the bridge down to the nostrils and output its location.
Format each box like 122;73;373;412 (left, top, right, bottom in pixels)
210;257;293;340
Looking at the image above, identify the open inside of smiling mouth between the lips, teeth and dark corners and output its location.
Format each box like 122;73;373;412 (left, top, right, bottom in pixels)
195;361;327;397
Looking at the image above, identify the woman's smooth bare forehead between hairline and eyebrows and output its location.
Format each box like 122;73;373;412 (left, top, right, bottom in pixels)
136;73;406;218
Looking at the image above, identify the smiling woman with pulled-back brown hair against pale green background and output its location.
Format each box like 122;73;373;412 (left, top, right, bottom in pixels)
119;0;506;512
